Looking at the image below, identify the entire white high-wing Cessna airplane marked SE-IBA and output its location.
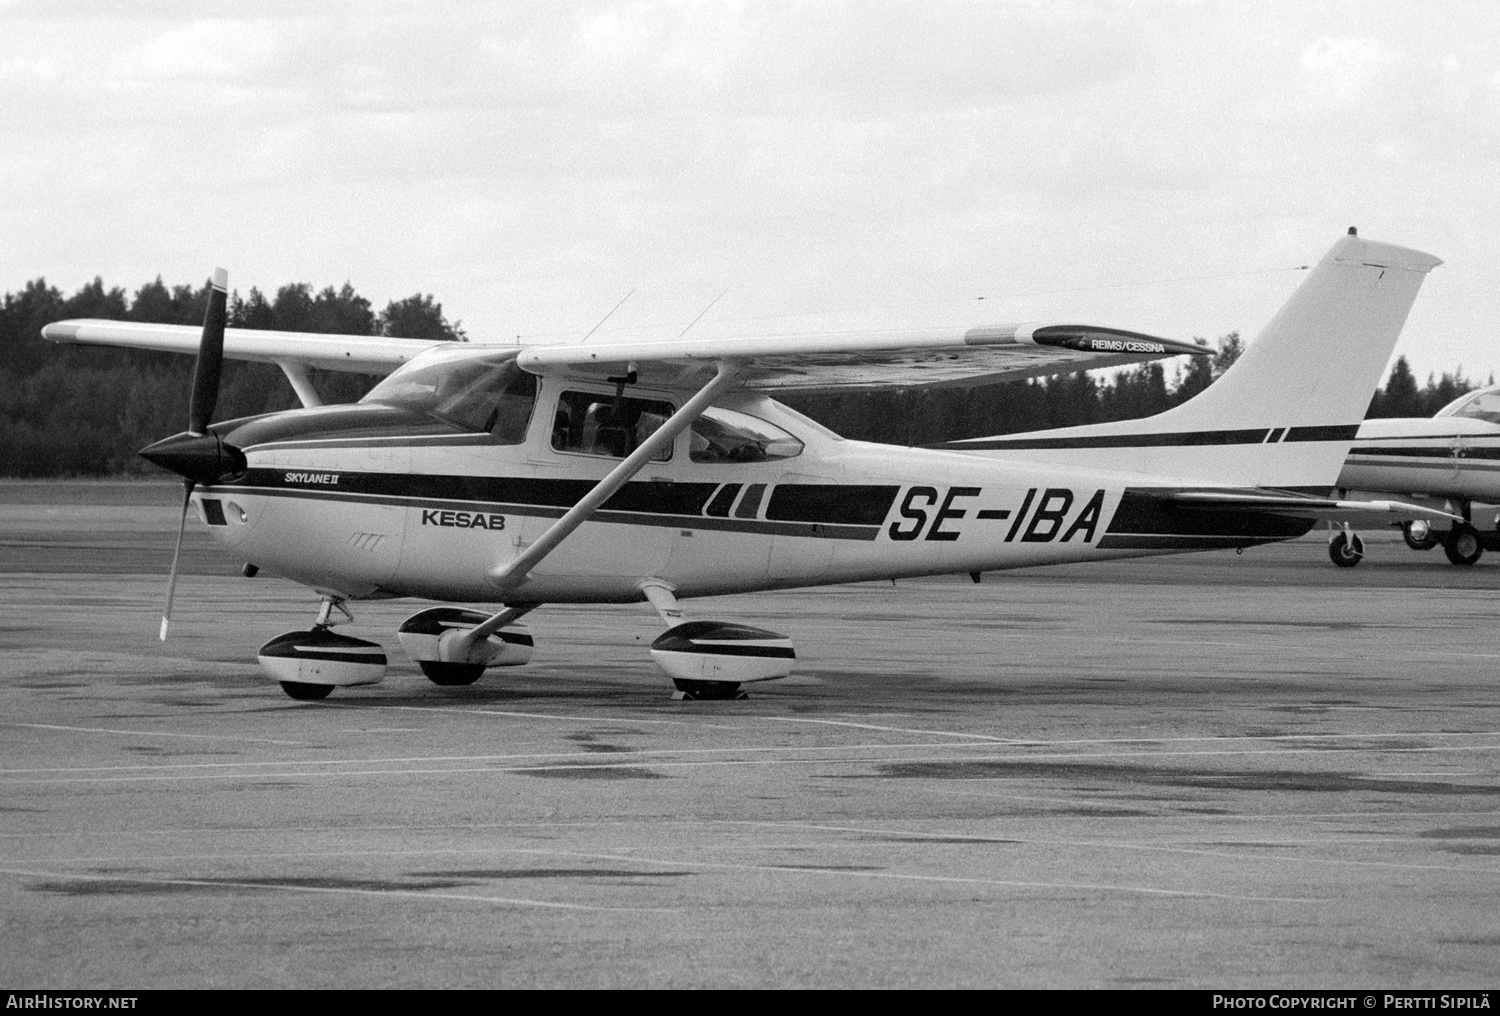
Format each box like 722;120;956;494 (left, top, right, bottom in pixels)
45;230;1448;698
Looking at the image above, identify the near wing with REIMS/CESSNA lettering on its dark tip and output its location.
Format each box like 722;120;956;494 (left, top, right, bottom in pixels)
519;324;1214;390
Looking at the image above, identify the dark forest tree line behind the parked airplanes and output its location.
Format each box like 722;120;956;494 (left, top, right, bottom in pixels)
0;278;1493;477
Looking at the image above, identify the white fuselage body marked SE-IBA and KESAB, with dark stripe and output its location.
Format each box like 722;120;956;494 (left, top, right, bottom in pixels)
194;378;1313;603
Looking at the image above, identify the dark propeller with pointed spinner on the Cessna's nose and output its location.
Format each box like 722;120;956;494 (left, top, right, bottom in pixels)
140;269;234;642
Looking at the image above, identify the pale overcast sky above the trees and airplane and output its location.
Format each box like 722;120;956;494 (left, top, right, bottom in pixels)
0;0;1500;380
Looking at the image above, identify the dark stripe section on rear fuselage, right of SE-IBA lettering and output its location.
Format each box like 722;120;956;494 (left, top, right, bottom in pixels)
1095;488;1317;551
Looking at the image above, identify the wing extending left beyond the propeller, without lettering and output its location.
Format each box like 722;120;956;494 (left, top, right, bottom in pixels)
42;320;446;374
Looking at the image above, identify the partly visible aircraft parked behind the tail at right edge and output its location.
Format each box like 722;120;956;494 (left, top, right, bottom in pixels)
1328;384;1500;567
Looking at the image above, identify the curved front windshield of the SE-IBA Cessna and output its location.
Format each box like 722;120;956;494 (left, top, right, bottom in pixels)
360;351;537;444
